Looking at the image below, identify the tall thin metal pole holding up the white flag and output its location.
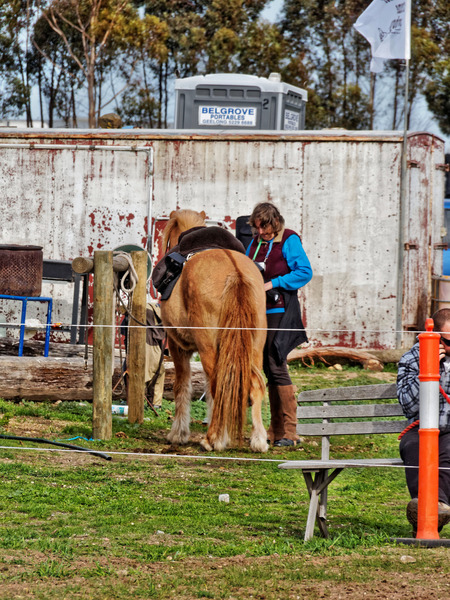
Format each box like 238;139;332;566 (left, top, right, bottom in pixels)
396;58;409;348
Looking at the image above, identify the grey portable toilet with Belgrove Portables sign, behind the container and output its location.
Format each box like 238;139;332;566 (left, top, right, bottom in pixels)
175;73;308;131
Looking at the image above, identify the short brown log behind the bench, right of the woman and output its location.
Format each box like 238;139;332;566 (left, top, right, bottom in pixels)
287;346;383;371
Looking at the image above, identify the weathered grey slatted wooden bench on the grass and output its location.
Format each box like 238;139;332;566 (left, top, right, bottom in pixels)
278;383;407;541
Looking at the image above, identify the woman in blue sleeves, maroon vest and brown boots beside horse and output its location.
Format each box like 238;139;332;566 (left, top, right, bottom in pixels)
246;202;312;446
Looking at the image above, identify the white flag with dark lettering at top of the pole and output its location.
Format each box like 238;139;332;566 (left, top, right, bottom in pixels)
353;0;411;73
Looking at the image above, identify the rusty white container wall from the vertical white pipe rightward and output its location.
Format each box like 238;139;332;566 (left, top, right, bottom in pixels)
149;132;443;348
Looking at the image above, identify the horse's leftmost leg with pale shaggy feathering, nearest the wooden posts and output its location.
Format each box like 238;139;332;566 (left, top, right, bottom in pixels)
167;338;192;444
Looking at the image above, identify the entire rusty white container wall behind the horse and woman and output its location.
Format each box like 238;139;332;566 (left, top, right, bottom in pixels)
0;130;444;348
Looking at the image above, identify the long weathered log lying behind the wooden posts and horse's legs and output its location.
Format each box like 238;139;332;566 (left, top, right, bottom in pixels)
0;356;205;401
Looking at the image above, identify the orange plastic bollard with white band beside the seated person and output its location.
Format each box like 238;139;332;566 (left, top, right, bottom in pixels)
416;319;440;540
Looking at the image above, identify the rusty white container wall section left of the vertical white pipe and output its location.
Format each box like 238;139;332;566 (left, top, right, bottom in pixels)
0;138;152;330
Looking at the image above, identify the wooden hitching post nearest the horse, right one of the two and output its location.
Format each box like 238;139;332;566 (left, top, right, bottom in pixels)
127;251;147;423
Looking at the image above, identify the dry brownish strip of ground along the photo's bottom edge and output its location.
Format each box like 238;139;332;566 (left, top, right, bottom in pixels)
0;552;450;600
